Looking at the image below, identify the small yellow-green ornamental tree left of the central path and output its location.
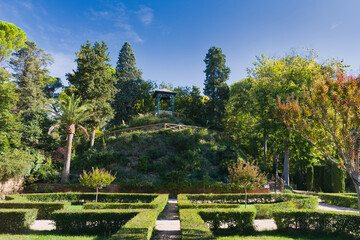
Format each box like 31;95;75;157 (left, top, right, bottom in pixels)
79;168;116;202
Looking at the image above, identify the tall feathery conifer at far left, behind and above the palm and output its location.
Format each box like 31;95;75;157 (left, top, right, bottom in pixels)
10;42;56;111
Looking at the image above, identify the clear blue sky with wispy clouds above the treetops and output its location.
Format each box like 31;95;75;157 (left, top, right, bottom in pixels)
0;0;360;88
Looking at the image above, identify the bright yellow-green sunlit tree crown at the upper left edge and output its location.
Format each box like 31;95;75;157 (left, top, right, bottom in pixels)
0;21;26;63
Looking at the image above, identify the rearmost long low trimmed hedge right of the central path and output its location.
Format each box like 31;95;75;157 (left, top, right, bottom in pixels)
178;193;318;209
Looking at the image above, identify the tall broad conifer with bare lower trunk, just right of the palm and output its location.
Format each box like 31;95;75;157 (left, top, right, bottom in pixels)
66;41;116;147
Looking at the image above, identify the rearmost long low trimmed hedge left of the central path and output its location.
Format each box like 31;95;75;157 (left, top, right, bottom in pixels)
7;192;158;203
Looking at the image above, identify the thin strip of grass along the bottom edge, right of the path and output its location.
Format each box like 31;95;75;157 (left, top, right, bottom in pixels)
216;231;353;240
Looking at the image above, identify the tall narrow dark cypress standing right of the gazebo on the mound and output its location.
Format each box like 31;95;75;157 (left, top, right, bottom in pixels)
204;47;230;128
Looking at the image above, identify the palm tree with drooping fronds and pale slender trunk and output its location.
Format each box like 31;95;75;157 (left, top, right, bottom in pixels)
48;95;92;183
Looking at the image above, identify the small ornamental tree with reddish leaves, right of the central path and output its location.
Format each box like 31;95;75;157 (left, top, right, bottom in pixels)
228;160;266;208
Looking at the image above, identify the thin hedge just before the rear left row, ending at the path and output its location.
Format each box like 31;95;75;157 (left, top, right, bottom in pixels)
84;194;169;209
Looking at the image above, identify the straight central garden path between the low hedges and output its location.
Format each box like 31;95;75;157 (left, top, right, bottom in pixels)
152;199;181;240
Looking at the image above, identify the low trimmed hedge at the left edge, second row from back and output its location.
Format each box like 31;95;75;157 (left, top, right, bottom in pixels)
0;200;70;219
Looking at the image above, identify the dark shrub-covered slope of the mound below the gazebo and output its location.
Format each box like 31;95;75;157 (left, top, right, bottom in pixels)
71;129;243;190
